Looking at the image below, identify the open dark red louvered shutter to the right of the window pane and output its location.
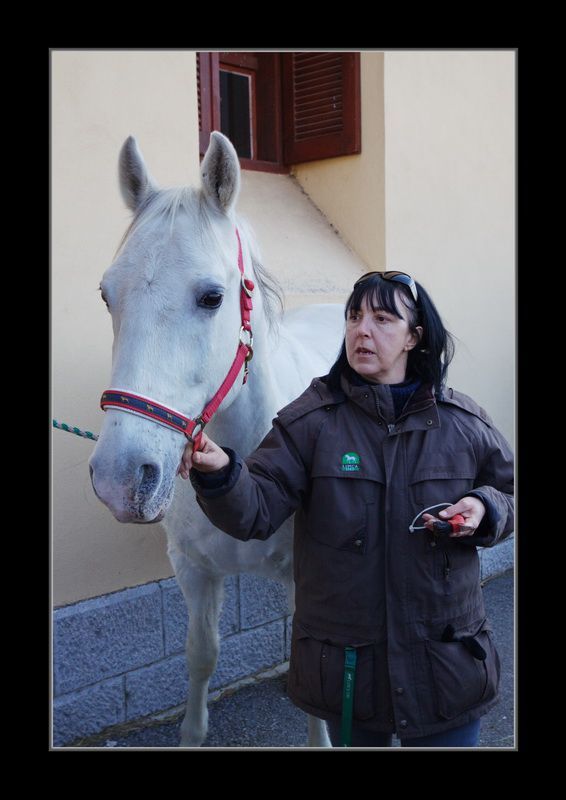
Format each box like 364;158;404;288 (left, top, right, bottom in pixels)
283;53;361;164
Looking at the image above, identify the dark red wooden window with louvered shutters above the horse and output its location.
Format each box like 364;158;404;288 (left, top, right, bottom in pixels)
197;52;361;172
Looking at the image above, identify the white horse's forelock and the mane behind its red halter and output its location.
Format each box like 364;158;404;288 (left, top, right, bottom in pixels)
116;186;284;328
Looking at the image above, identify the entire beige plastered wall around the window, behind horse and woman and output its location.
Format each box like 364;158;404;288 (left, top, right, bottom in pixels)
52;51;514;605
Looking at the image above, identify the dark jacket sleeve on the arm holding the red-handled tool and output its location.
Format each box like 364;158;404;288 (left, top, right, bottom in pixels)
459;426;514;547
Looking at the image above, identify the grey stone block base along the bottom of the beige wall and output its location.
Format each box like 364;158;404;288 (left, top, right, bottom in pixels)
53;537;514;746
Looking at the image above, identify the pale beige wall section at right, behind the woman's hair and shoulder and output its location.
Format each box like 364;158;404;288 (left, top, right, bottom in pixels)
384;50;515;443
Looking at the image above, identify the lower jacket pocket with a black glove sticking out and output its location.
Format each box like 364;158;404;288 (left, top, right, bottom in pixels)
425;621;500;719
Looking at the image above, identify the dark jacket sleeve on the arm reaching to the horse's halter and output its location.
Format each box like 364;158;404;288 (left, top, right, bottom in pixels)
190;419;308;541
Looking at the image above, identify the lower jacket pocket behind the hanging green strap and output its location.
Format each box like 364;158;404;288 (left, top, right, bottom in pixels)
289;630;375;720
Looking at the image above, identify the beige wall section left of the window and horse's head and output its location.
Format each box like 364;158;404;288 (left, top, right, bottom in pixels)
51;51;199;605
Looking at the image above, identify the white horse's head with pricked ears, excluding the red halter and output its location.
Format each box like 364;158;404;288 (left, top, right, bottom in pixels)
90;132;259;522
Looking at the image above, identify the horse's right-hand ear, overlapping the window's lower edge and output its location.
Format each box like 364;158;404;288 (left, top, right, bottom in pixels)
200;131;240;213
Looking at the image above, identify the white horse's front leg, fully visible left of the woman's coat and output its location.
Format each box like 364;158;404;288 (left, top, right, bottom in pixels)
174;558;224;747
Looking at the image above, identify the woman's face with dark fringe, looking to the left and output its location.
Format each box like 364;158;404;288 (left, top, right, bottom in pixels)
345;292;422;383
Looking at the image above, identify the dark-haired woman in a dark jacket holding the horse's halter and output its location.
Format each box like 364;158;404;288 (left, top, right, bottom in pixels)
181;271;513;747
